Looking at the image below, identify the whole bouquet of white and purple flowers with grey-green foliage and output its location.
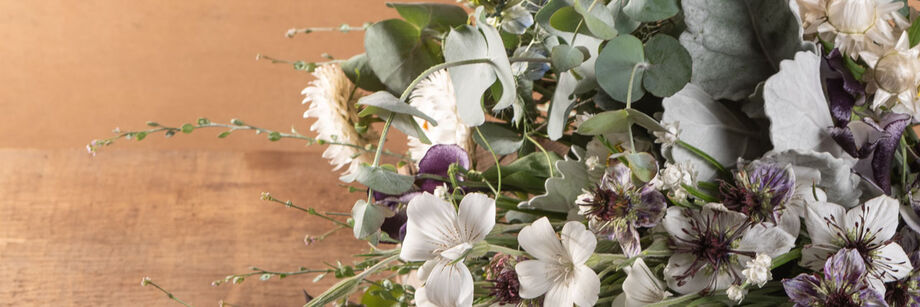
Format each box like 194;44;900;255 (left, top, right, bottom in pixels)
89;0;920;306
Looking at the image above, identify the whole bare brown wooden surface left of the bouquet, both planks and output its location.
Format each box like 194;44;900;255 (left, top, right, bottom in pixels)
0;0;438;306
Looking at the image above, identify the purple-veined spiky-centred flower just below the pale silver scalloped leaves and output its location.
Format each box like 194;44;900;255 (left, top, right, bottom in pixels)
719;163;795;224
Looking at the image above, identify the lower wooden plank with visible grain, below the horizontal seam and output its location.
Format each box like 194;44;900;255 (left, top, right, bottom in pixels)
0;149;367;306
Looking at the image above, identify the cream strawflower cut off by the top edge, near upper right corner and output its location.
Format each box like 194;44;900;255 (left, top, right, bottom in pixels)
796;0;909;59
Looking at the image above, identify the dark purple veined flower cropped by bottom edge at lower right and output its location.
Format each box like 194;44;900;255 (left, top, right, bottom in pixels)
783;248;888;307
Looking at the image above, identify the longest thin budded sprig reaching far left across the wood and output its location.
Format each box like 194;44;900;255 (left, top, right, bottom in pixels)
86;117;410;161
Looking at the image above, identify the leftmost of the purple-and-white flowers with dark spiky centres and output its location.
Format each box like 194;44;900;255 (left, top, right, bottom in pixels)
575;161;667;257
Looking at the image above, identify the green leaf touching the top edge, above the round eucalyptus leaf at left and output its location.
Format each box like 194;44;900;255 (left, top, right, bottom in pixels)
387;2;468;32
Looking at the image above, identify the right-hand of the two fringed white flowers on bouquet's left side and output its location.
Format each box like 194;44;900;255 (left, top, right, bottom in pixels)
409;70;473;161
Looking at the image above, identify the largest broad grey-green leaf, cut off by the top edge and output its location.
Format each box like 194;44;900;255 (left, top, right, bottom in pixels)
680;0;805;100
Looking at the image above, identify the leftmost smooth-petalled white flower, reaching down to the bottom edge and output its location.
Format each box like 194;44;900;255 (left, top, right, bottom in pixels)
399;193;495;307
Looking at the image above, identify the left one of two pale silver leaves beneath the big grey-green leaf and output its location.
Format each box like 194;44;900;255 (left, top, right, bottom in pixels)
661;83;765;181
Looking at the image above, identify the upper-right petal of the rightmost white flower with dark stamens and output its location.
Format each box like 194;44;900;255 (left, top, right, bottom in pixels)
846;195;898;244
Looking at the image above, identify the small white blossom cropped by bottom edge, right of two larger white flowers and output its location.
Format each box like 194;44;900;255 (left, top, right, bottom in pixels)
611;258;671;307
